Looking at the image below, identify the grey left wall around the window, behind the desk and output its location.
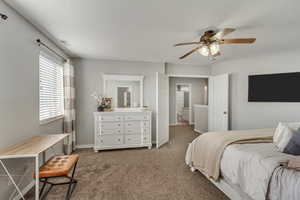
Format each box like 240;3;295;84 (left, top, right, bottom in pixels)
0;1;67;199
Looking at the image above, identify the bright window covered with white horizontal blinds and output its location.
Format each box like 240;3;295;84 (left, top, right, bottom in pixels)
39;52;64;123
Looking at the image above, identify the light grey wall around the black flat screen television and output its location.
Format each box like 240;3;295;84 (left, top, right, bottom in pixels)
212;49;300;129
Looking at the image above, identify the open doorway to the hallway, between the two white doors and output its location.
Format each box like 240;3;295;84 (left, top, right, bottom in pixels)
169;76;208;132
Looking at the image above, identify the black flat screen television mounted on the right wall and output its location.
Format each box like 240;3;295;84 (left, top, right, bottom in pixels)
248;72;300;102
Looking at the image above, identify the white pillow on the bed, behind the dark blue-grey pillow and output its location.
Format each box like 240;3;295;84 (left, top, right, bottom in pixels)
273;122;300;152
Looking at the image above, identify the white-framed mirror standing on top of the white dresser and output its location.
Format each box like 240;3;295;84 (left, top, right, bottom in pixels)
103;74;144;109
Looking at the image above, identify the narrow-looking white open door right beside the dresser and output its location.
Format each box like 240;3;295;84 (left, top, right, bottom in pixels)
156;72;169;148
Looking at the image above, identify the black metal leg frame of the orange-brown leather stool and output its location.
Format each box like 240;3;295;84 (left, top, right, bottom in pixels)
40;161;78;200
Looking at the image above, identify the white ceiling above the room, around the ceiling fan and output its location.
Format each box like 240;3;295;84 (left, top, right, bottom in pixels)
6;0;300;65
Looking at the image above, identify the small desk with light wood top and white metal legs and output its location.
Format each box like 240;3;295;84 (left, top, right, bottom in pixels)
0;134;69;200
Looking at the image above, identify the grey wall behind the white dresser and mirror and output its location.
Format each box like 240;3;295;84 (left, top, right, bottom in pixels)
74;59;165;146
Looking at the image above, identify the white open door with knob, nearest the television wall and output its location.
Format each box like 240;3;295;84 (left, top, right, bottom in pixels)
208;74;229;131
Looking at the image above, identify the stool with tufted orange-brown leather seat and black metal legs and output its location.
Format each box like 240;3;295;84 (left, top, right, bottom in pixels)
39;154;79;199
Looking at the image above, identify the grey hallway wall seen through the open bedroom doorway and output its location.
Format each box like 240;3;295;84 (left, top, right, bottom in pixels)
169;77;208;124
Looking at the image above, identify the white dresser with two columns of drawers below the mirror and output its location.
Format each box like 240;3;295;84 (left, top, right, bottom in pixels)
94;111;152;151
